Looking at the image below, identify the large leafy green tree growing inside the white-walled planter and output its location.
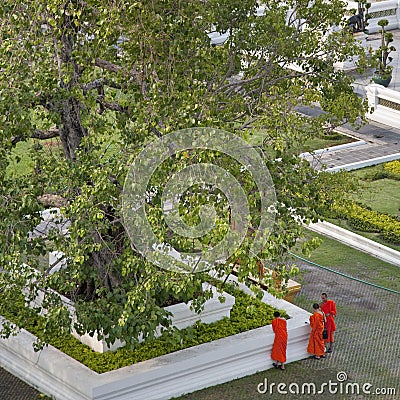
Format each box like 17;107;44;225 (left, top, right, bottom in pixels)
0;0;364;345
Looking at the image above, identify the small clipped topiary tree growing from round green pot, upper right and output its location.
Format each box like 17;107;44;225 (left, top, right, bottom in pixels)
371;19;396;79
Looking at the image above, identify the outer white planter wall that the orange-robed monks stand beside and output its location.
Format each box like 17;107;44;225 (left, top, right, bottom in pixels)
0;277;310;400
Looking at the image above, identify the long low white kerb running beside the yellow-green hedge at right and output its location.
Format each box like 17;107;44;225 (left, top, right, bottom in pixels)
307;221;400;267
